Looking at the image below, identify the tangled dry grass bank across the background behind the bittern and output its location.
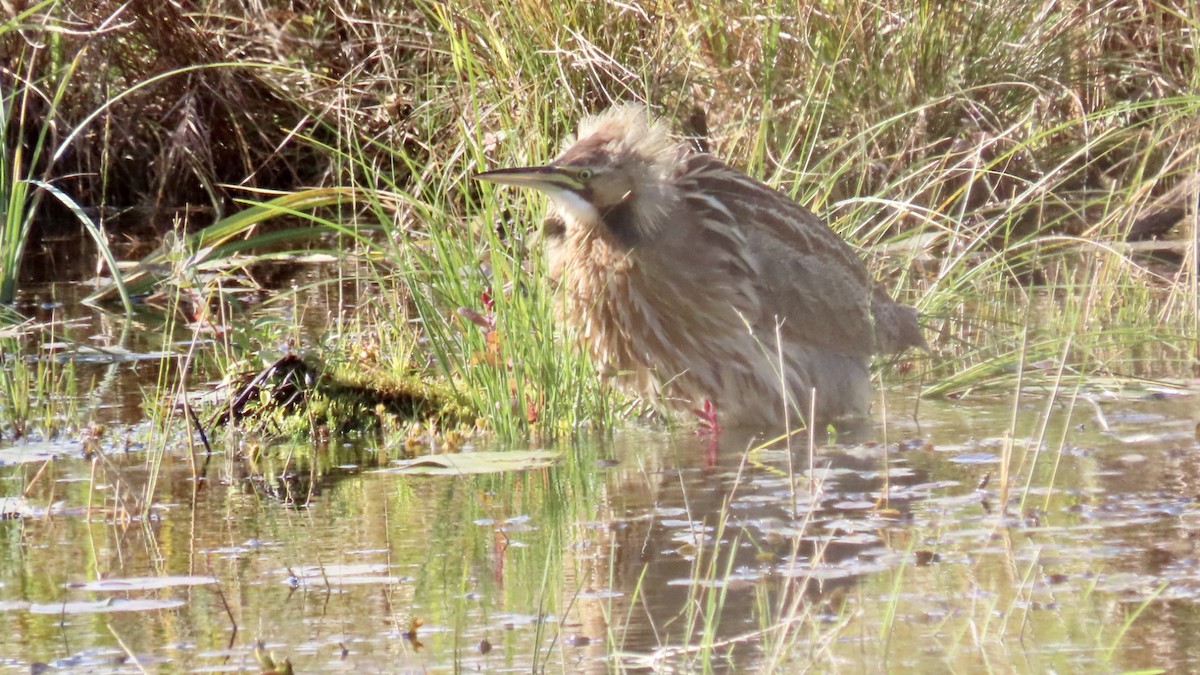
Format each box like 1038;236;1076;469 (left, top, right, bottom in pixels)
7;0;1198;237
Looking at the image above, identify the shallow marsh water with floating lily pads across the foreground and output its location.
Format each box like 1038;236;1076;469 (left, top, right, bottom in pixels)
0;282;1200;673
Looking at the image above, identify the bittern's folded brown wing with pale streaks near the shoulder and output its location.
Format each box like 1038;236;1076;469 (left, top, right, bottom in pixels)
678;155;875;356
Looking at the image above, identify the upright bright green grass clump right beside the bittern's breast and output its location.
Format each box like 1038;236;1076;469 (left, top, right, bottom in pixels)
393;178;613;437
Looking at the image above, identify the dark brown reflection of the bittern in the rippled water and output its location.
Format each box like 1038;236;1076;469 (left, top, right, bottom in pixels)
583;426;926;669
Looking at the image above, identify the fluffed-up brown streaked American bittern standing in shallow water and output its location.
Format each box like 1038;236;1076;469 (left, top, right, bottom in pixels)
475;106;925;426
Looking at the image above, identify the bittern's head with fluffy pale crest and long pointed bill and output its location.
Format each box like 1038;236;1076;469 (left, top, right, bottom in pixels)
475;106;686;249
